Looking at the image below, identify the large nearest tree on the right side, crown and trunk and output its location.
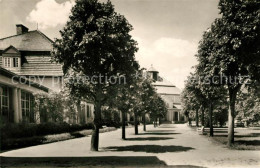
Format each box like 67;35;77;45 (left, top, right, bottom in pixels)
199;0;260;146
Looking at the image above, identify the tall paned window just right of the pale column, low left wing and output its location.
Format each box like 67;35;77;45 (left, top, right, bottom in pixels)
21;91;34;122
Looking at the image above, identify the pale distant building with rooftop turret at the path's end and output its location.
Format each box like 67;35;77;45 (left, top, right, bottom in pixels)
147;66;184;122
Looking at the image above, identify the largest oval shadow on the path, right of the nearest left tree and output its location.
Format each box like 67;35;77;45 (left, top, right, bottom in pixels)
104;145;194;153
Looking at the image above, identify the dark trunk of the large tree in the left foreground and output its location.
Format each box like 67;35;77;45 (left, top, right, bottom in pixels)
90;100;101;151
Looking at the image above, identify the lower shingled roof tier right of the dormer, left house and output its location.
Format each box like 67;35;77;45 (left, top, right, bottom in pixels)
13;55;63;76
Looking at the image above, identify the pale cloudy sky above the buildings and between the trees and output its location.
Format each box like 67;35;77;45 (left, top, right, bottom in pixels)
0;0;219;89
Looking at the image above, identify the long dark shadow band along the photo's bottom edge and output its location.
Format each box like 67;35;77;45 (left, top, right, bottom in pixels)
0;156;205;168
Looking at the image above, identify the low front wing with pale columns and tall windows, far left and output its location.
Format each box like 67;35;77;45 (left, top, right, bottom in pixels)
0;67;49;123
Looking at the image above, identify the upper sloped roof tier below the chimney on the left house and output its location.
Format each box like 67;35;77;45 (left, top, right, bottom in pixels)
0;30;53;51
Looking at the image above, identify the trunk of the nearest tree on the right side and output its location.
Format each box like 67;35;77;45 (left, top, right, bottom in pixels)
227;87;240;146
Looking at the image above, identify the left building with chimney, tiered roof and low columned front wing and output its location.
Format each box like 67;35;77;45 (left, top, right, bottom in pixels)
0;24;94;123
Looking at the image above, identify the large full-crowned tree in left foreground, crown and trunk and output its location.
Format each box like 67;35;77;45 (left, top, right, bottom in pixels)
53;0;138;151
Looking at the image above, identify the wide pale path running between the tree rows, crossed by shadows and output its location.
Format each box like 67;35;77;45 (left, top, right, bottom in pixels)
0;124;260;168
